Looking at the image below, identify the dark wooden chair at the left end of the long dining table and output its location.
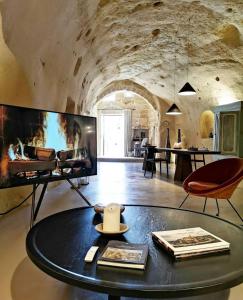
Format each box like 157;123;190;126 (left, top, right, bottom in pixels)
144;146;170;178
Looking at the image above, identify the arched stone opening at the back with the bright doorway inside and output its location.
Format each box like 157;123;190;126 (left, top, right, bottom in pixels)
92;90;158;158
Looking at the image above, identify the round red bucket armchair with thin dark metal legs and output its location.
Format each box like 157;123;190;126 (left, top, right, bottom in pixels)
179;158;243;222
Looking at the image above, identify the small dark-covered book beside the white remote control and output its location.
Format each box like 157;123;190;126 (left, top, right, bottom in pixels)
97;240;148;270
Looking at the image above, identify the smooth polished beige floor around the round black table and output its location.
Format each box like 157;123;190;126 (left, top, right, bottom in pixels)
0;162;243;300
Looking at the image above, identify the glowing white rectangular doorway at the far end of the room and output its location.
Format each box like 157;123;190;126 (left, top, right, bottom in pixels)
101;115;124;157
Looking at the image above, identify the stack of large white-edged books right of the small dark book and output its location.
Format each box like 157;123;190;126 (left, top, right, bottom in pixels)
152;227;230;259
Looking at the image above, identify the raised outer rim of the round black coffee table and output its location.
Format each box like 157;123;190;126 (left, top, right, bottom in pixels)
26;204;243;298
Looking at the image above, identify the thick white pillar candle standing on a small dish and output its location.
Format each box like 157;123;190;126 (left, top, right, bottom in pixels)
103;203;121;232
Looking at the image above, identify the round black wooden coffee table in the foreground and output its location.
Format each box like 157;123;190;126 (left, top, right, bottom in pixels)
26;205;243;299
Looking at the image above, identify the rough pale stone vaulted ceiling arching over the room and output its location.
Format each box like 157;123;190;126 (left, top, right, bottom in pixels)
1;0;243;119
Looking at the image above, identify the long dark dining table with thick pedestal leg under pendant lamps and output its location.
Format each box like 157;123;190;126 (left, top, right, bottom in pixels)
157;148;220;181
